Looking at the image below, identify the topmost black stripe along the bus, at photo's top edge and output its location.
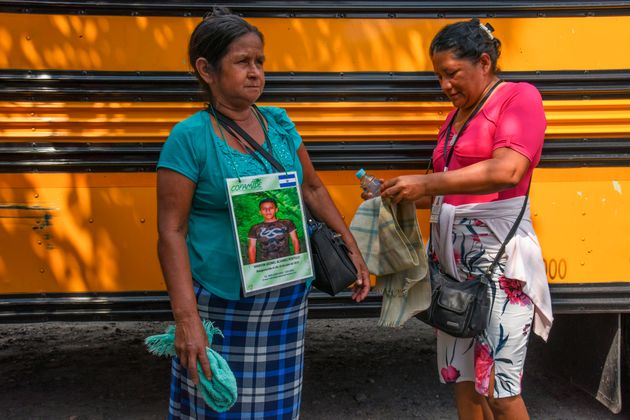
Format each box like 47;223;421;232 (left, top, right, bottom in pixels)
0;0;630;18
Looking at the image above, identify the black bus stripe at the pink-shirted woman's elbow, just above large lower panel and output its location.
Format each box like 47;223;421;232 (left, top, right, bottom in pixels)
0;138;630;173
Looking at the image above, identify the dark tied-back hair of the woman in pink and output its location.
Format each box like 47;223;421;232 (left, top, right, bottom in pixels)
429;18;501;72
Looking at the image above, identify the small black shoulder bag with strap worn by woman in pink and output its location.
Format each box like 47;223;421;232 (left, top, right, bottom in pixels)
417;80;531;338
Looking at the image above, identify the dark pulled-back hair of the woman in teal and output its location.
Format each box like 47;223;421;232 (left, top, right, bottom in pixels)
188;7;265;101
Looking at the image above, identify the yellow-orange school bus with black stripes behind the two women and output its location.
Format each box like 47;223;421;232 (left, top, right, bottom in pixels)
0;0;630;411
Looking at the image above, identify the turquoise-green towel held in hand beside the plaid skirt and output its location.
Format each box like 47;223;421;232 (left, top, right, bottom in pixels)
144;320;238;413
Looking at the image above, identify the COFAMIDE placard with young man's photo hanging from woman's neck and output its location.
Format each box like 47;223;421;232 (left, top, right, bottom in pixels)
226;172;313;297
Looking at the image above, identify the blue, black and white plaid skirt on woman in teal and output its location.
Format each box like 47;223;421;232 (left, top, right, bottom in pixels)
169;283;309;419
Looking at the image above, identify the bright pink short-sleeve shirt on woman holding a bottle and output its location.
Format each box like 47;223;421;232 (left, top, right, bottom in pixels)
433;82;547;205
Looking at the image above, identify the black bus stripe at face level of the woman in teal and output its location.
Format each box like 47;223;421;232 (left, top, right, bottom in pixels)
0;70;630;102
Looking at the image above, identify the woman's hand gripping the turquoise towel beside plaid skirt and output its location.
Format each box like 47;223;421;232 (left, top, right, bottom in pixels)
175;316;212;384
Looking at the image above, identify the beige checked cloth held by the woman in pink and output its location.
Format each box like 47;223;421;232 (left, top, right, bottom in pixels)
350;197;431;327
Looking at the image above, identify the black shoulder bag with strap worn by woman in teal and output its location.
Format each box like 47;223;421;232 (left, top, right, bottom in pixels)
215;106;357;296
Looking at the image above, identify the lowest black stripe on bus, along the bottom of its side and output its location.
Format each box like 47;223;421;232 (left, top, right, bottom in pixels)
0;279;630;324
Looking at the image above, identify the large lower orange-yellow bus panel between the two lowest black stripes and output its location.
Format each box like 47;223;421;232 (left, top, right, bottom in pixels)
0;168;630;294
